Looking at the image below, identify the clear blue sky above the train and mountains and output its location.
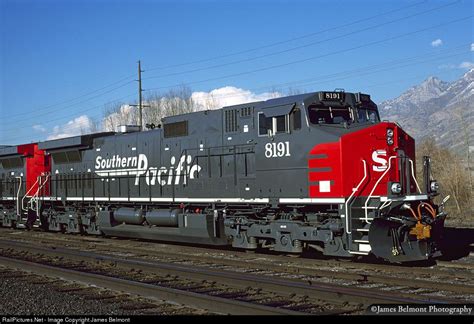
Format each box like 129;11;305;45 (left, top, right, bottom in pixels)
0;0;474;144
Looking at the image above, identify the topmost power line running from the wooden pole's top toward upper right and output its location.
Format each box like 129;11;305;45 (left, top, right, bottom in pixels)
147;0;427;71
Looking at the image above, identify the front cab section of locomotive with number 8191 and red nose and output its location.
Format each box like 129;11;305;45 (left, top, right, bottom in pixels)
250;91;446;262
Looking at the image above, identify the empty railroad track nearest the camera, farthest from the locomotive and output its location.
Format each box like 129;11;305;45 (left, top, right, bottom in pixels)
0;240;466;314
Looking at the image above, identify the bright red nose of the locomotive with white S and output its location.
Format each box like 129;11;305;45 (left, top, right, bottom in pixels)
308;122;416;198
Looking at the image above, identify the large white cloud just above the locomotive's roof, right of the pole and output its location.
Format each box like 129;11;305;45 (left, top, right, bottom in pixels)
191;86;282;109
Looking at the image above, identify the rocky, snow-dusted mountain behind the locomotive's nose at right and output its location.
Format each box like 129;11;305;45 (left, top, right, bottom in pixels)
378;69;474;154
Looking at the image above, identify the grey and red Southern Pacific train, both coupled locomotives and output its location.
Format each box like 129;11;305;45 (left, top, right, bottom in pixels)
0;91;447;263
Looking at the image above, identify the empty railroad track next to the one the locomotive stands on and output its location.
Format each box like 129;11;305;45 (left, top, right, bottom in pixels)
1;229;474;298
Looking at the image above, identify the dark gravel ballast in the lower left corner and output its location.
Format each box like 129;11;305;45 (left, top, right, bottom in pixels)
0;260;206;316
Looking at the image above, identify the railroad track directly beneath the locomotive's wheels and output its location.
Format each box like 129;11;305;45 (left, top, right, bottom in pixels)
0;228;474;279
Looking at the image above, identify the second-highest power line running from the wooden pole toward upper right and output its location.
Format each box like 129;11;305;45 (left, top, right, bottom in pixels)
145;0;459;79
